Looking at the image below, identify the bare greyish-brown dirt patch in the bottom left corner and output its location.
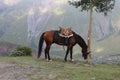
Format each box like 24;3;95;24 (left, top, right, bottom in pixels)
0;62;31;80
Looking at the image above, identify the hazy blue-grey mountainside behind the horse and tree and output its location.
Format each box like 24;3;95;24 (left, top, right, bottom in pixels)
0;0;120;56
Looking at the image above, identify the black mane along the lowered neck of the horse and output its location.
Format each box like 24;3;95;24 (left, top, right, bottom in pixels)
73;31;87;48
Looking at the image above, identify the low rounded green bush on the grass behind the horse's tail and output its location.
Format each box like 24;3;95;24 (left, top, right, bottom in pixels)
10;46;32;56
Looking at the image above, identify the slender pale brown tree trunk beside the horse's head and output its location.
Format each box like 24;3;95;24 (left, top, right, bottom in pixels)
87;0;93;62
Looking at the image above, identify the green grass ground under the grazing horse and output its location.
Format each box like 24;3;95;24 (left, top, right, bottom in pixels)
0;57;120;80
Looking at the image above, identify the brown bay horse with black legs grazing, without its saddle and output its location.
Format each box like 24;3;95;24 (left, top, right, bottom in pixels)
37;30;89;61
